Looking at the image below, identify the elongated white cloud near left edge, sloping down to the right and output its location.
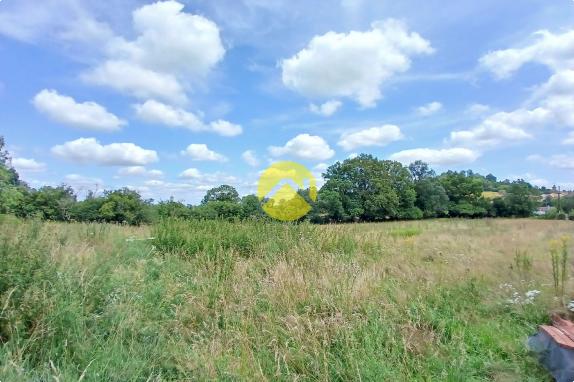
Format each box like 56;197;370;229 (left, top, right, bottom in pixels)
32;89;127;131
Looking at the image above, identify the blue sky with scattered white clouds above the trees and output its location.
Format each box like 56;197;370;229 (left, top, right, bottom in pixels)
0;0;574;203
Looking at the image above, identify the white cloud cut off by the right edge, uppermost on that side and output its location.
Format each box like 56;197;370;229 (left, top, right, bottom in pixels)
480;30;574;78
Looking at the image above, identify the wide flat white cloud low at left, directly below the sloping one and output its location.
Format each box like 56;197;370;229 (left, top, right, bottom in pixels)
52;138;158;166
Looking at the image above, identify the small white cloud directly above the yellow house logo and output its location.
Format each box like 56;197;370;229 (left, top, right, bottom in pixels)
269;134;335;161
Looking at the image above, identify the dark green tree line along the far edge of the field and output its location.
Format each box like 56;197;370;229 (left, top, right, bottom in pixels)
0;137;574;225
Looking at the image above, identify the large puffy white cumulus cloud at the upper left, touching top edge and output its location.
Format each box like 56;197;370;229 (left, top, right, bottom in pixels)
83;0;225;103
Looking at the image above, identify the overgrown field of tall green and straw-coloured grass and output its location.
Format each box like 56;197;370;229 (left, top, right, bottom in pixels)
0;217;574;382
